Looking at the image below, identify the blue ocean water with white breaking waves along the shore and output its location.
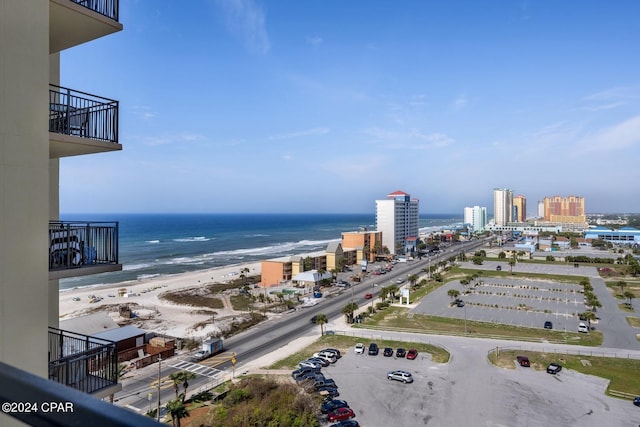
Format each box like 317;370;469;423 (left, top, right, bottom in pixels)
60;214;462;289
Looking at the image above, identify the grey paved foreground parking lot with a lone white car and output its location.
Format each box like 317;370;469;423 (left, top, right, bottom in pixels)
323;340;640;427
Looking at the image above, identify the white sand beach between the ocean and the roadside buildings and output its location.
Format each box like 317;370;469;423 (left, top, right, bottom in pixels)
59;262;261;338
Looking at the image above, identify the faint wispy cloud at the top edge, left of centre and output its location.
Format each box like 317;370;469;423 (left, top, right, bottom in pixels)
217;0;270;54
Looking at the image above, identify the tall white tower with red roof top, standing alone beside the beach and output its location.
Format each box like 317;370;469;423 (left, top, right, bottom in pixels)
376;191;419;255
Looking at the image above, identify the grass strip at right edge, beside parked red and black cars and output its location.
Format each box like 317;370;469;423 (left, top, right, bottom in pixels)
489;350;640;395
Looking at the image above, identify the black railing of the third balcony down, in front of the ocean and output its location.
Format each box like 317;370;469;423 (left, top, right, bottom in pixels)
49;221;118;271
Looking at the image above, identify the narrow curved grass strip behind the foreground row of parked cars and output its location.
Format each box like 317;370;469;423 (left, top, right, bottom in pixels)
268;335;451;369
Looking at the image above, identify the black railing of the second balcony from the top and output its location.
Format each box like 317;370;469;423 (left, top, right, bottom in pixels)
49;84;118;143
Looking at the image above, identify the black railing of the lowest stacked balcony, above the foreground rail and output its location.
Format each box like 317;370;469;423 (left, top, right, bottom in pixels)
49;327;118;394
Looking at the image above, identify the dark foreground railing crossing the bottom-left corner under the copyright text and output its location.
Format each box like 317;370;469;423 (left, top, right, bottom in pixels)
0;362;162;427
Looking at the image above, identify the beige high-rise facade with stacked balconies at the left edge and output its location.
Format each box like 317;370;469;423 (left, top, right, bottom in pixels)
0;0;122;416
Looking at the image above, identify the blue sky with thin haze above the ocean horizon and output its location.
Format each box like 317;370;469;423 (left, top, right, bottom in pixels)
60;0;640;215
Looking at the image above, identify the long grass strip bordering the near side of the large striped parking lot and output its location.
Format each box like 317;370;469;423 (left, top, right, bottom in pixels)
354;307;602;346
